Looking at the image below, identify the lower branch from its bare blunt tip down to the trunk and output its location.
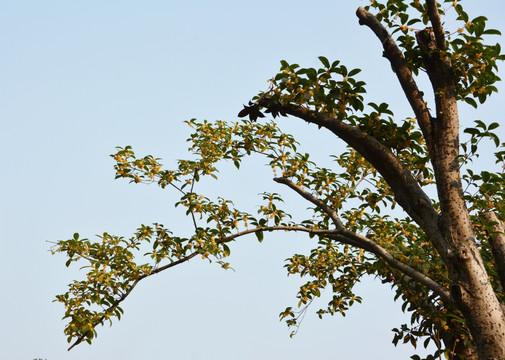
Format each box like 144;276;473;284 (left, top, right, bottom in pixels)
274;178;450;304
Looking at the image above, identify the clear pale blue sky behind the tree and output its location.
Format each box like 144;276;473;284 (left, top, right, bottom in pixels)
0;0;505;360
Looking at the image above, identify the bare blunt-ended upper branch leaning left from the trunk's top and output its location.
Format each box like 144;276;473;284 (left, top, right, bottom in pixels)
356;6;432;148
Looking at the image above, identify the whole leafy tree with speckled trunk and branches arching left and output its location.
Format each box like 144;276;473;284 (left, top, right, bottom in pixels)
53;0;505;359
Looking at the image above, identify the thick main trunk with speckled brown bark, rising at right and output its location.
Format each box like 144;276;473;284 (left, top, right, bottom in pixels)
418;29;505;359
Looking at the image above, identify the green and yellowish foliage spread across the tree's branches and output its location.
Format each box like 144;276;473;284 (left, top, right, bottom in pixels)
53;0;505;359
